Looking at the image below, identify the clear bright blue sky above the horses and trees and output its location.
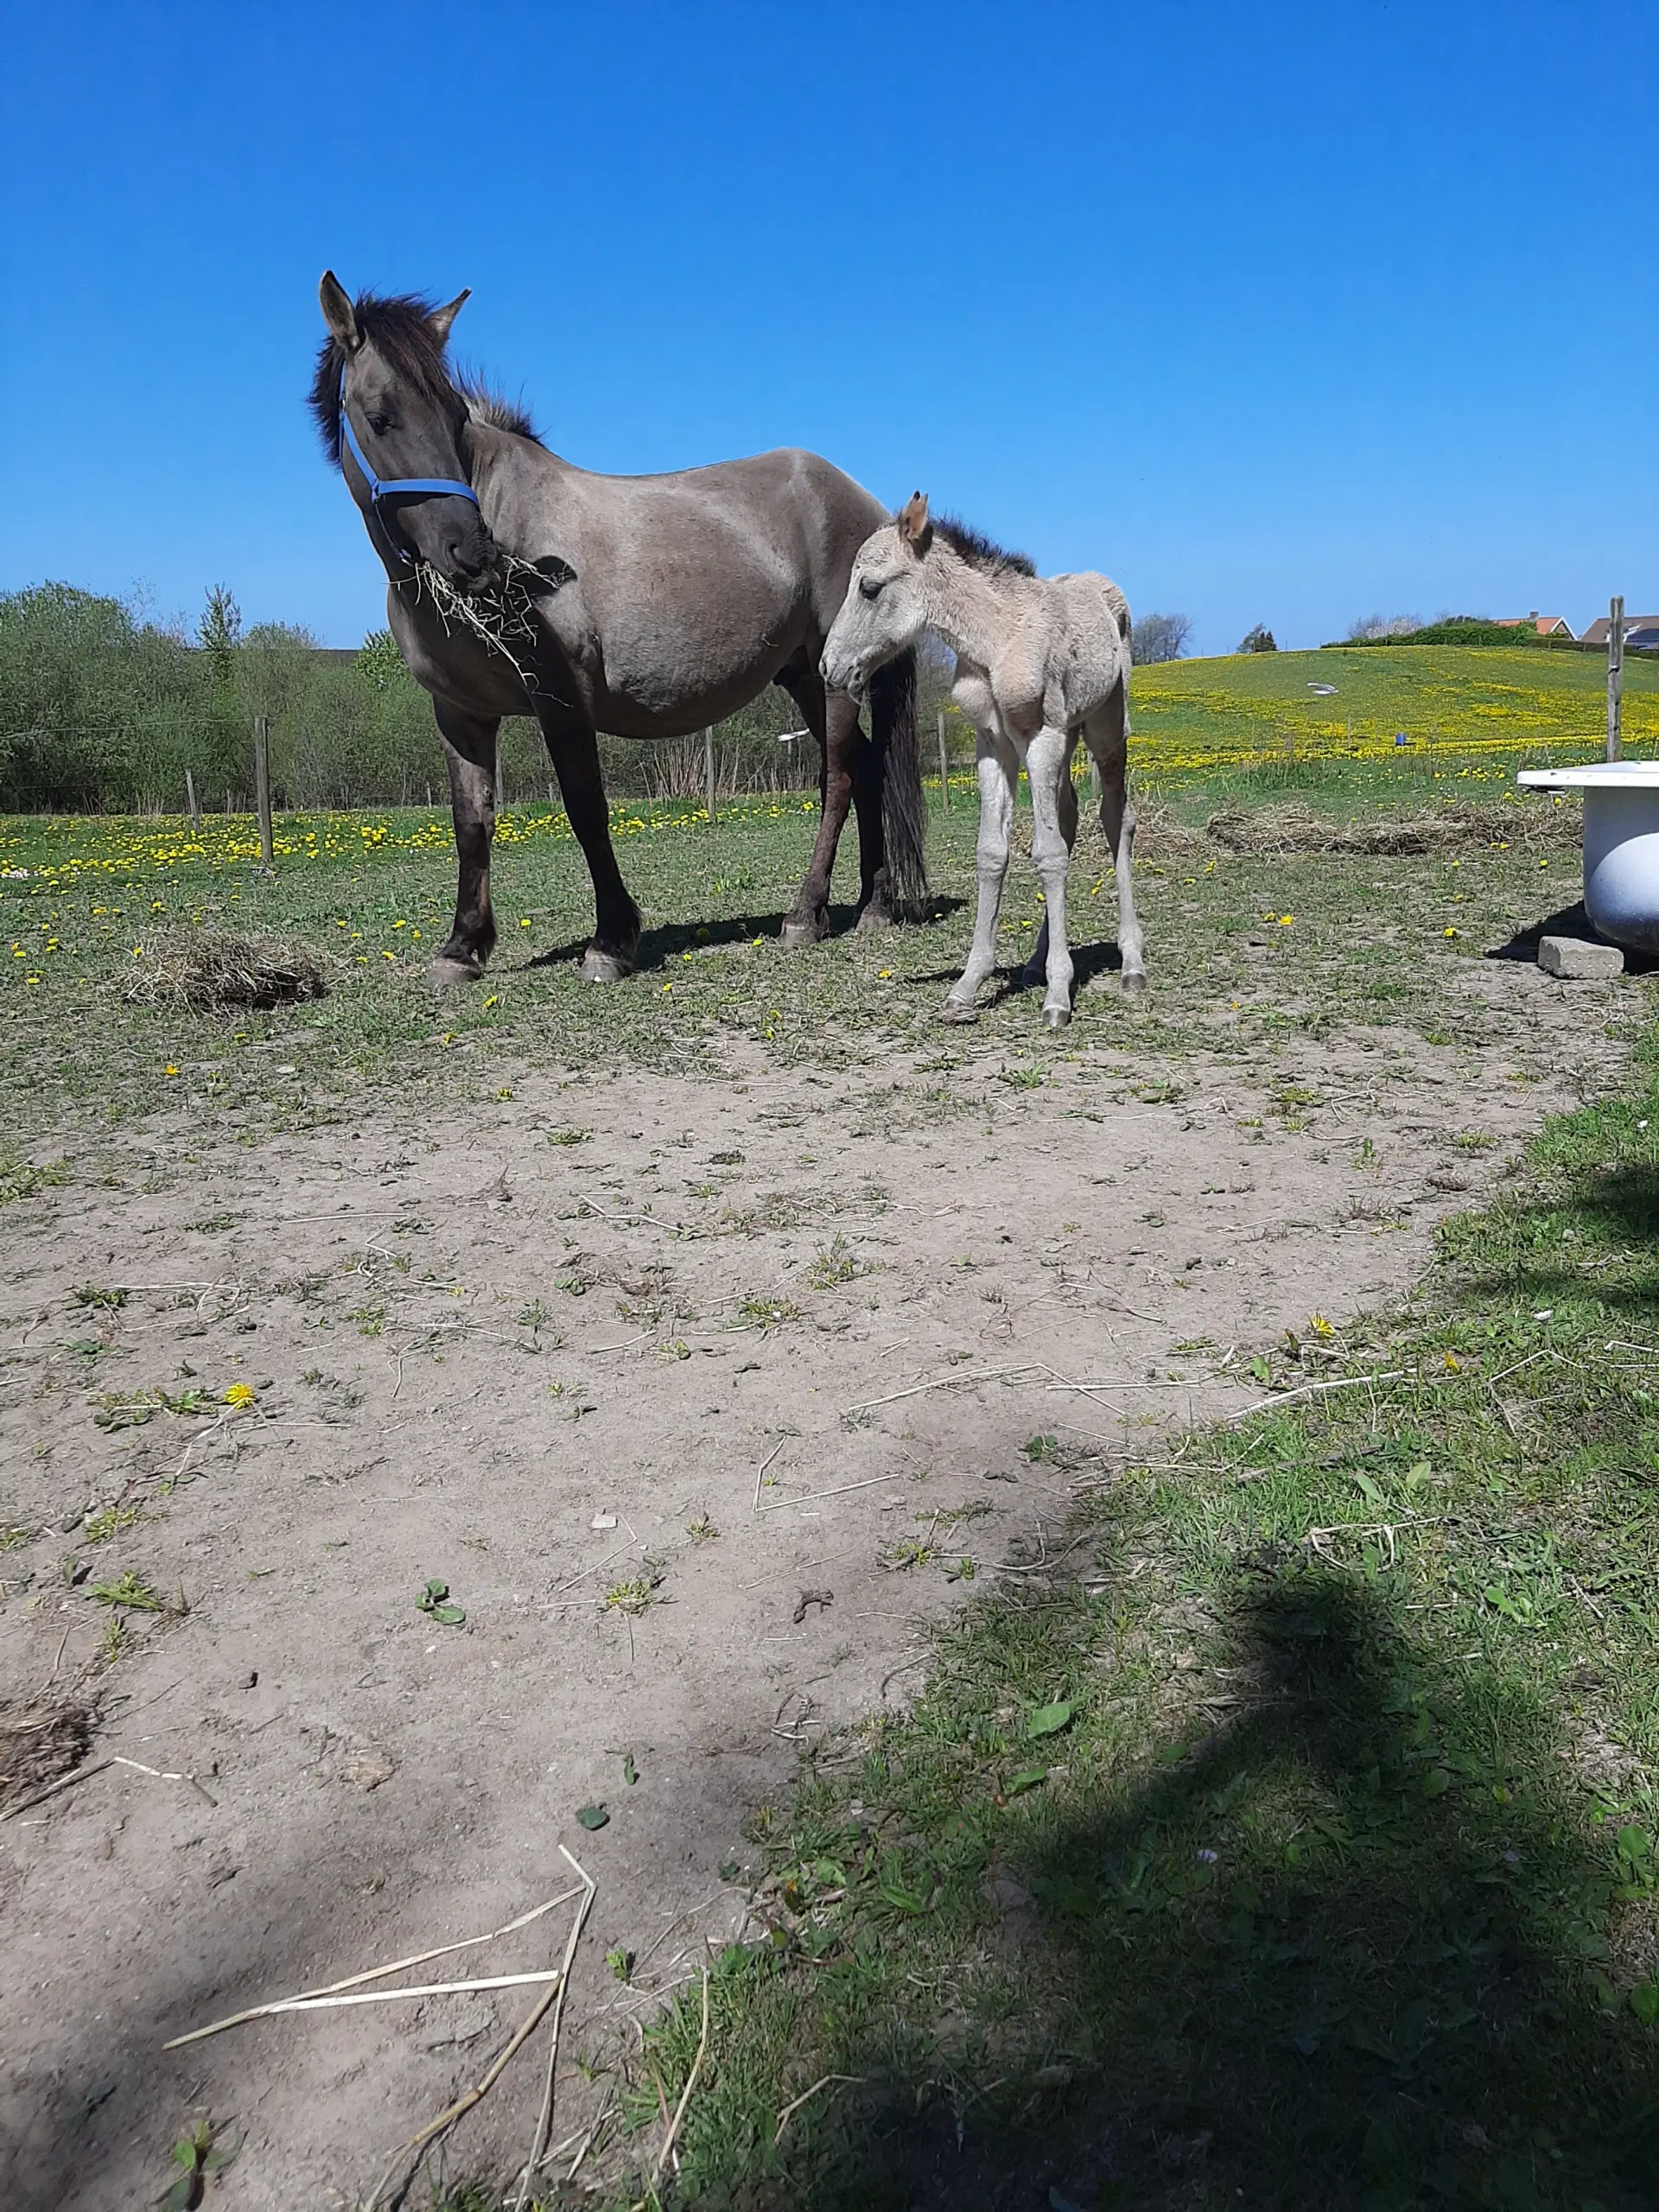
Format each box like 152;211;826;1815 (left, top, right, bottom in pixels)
0;0;1659;652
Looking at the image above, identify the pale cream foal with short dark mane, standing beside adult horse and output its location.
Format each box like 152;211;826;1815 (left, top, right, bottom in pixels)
821;491;1146;1028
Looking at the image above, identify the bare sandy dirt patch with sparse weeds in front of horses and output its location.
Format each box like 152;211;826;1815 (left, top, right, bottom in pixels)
0;963;1621;2212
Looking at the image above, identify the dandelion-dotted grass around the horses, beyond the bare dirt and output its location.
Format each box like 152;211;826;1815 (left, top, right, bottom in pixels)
0;646;1659;1159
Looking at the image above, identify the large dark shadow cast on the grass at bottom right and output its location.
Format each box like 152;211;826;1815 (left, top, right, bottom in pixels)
703;1560;1659;2212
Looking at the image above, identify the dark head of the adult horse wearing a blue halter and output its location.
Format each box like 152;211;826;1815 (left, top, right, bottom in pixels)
312;270;500;591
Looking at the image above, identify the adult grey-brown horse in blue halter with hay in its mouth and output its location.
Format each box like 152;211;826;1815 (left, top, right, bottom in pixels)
312;272;927;982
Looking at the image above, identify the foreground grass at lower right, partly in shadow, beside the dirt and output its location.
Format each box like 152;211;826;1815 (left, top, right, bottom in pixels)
588;1033;1659;2212
